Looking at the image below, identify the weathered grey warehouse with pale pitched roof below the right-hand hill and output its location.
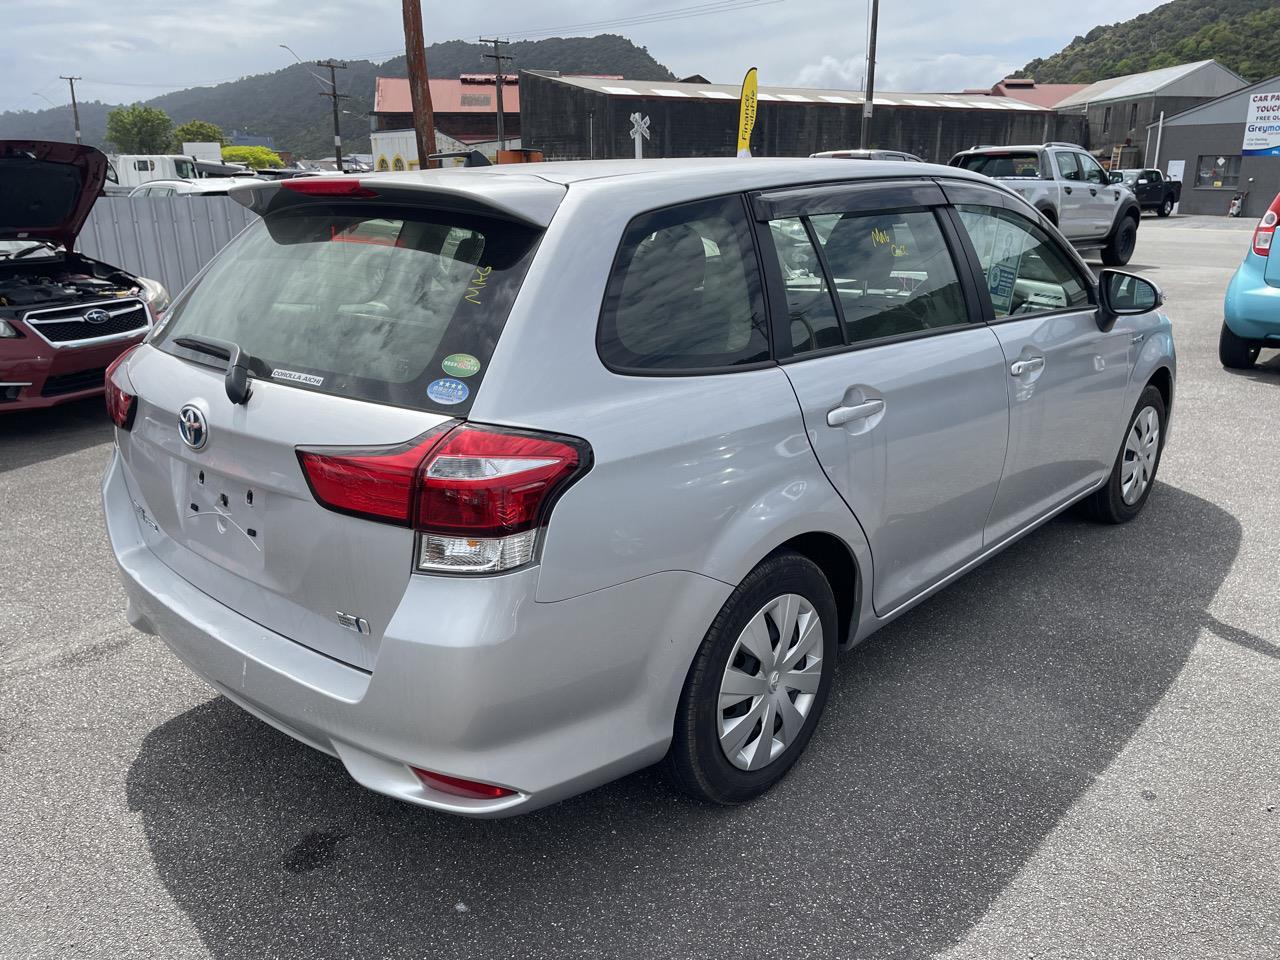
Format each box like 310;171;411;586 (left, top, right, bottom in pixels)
1056;60;1244;169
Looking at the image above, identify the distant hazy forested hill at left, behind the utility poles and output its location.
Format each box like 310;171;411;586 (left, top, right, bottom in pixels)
0;33;673;159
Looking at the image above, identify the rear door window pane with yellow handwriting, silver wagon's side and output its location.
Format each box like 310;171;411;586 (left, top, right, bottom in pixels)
812;210;969;343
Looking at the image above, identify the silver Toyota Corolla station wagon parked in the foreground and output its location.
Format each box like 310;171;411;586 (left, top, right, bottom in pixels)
104;159;1174;817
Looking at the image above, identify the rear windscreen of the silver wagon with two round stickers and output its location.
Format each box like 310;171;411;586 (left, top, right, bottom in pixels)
154;204;539;413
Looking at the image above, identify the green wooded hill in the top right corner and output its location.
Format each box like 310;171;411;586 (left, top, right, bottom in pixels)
1015;0;1280;83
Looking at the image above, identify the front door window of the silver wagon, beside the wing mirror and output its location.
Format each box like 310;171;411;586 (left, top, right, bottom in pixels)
956;205;1089;319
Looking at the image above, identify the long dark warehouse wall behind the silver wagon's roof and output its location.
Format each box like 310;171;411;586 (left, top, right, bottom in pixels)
520;73;1084;163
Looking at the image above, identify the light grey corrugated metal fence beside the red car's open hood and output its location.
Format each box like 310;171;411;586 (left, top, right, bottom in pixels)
76;196;257;294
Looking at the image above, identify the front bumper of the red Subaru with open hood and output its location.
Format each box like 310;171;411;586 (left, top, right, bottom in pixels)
0;330;147;415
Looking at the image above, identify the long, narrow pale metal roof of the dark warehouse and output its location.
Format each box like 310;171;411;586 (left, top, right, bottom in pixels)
538;74;1043;113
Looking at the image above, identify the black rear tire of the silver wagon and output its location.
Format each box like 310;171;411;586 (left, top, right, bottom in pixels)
663;550;837;805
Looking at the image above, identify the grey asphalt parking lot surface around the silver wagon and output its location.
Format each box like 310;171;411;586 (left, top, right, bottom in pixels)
0;218;1280;960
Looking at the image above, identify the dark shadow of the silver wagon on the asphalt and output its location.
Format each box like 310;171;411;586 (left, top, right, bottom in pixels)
128;484;1239;959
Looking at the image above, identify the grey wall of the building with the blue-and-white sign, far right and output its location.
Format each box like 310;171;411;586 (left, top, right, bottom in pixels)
1151;120;1280;219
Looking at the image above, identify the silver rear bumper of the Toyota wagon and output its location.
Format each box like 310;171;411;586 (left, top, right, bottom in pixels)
102;454;732;817
